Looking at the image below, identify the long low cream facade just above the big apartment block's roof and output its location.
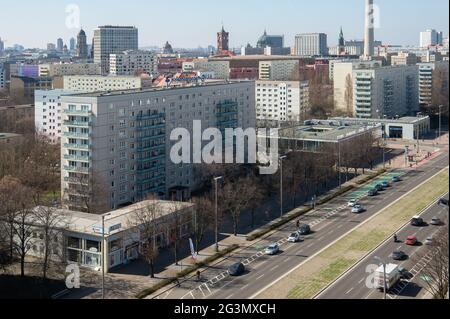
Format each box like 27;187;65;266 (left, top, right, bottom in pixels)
63;75;143;92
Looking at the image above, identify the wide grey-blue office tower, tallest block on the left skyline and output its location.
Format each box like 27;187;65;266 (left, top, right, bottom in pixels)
94;26;138;74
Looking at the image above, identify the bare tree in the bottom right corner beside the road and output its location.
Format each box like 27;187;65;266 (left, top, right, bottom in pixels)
414;221;449;299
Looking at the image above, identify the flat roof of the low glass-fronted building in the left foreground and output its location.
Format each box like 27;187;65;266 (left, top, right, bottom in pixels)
34;200;194;236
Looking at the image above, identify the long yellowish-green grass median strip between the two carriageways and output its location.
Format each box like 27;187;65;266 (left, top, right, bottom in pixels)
257;168;449;299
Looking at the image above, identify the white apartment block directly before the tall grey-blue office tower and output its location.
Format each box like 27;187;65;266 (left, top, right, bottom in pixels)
109;50;158;77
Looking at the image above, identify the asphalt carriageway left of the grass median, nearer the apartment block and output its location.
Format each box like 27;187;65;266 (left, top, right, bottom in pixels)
153;153;449;299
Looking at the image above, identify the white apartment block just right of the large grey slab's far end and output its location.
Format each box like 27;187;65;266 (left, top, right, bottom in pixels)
255;81;309;122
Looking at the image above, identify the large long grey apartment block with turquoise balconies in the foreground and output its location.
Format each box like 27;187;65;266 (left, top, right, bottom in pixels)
61;81;256;214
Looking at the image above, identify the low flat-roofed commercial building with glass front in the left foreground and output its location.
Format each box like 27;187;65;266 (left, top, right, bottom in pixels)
21;200;194;273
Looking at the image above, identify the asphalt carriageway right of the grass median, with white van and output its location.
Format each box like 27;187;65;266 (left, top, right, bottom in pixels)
317;194;448;299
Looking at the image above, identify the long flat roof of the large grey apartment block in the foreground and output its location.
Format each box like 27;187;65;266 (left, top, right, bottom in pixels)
65;80;255;97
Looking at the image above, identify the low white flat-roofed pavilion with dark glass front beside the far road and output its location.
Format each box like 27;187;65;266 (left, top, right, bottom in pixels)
330;116;430;140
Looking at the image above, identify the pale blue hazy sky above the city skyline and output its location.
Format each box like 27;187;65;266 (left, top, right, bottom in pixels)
0;0;449;48
